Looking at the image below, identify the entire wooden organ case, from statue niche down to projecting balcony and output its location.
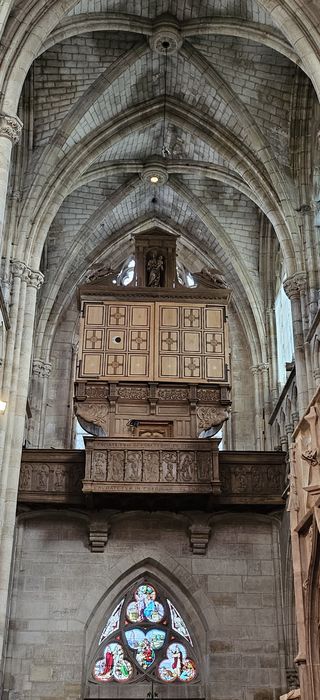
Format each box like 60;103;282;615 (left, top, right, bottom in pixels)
75;230;231;494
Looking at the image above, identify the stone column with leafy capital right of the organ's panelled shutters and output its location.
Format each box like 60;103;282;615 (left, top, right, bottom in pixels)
283;272;309;415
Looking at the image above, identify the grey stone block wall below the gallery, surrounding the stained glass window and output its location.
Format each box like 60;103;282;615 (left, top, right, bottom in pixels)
5;511;286;700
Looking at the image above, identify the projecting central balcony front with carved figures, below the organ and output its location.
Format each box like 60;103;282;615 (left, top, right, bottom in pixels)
83;438;220;493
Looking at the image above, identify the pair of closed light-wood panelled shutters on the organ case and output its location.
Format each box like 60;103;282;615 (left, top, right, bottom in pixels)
79;301;228;383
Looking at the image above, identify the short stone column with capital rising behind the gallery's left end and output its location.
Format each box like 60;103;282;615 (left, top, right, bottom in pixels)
28;358;52;447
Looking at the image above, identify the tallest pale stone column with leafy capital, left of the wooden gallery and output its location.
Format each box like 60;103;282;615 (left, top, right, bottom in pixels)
0;266;43;676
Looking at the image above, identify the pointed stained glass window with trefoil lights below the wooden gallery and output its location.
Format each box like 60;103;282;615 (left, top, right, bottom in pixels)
92;581;198;684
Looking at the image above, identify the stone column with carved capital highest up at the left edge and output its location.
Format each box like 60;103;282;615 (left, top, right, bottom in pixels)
0;112;22;260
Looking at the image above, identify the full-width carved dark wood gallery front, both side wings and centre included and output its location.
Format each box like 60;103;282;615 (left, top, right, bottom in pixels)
19;452;285;505
